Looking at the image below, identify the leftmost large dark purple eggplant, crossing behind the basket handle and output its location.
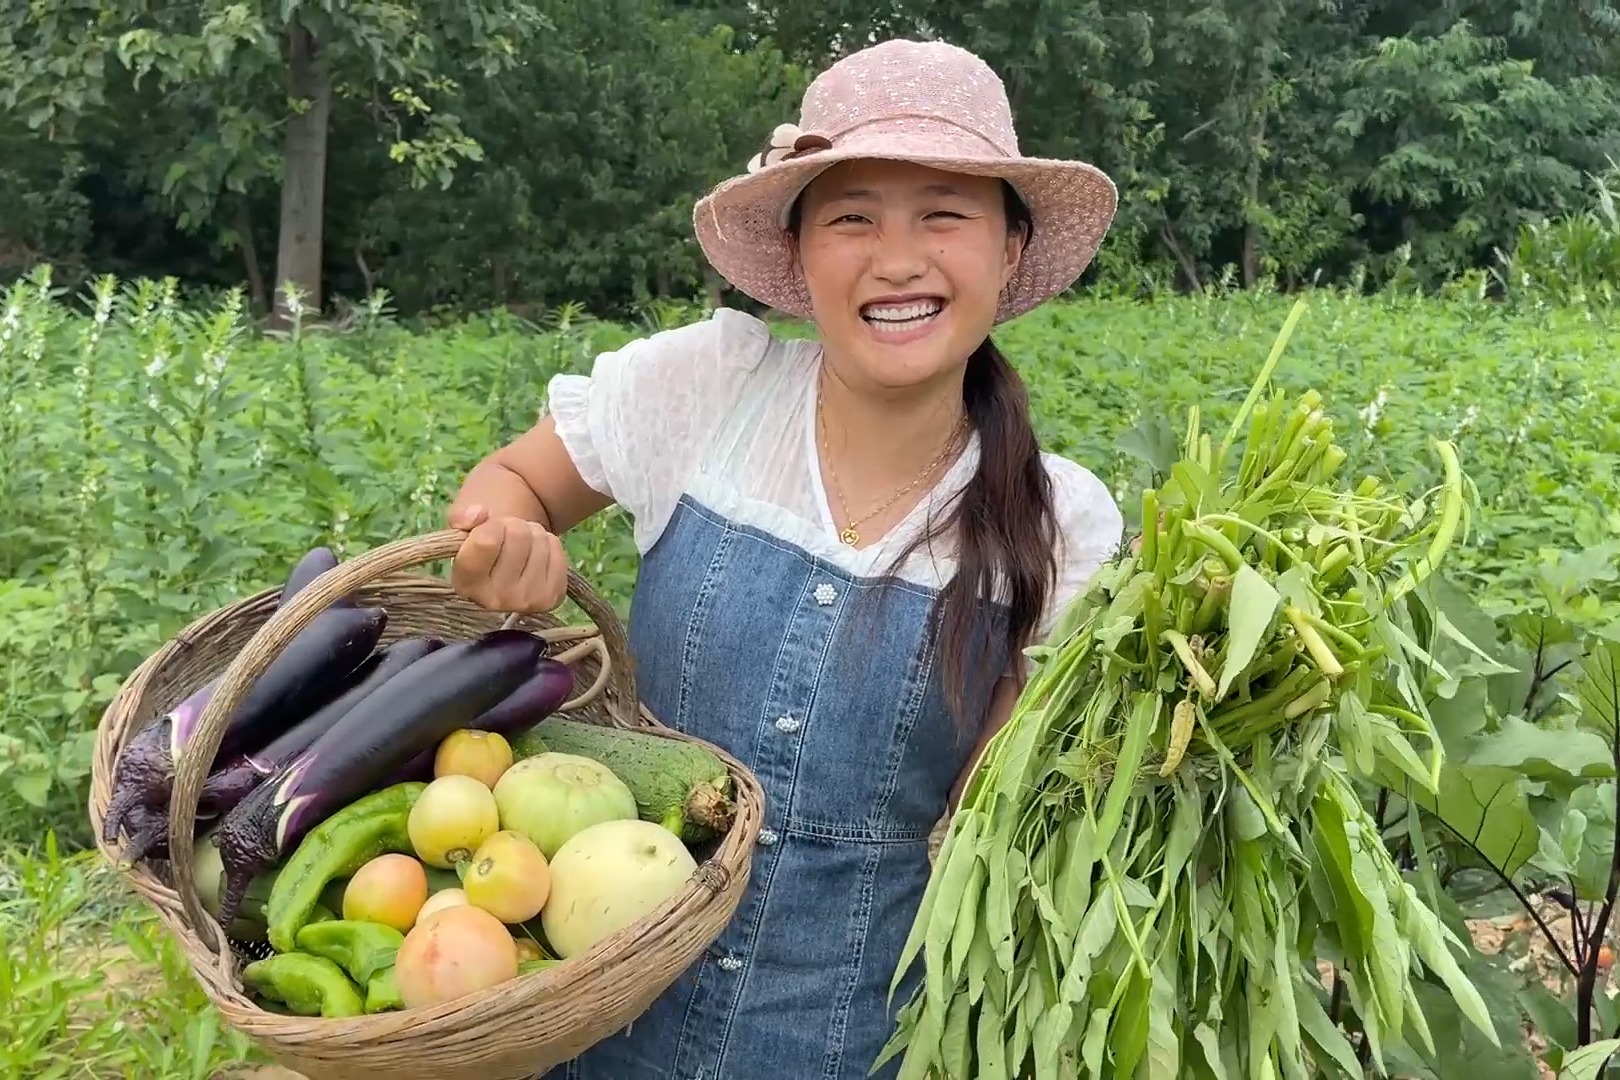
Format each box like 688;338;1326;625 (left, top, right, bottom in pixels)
102;607;387;844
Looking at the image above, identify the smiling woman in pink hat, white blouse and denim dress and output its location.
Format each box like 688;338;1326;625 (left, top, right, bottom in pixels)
450;33;1123;1080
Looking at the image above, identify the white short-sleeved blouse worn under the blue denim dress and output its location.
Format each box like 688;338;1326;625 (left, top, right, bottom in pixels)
548;308;1124;667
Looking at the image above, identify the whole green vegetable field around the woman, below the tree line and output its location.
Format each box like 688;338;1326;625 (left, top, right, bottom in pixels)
9;268;1620;1080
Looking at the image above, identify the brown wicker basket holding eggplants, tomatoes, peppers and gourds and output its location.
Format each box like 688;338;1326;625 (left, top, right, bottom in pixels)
89;531;763;1080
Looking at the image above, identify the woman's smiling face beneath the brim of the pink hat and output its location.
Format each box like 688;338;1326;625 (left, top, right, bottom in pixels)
797;160;1022;399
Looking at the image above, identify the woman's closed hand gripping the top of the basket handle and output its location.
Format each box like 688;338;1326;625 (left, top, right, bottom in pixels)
450;505;569;614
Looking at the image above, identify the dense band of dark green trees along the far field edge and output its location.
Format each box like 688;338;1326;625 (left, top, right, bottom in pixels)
0;0;1620;313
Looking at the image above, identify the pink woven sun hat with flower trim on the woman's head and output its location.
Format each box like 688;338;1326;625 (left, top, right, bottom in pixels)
692;40;1118;322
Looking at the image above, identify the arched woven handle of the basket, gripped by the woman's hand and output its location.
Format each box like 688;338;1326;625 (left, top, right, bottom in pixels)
168;529;640;955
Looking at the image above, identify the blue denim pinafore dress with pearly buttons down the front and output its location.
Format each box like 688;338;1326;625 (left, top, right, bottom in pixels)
548;489;1006;1080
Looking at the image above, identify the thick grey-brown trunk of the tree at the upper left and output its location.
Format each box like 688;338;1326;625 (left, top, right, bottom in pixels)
272;19;332;325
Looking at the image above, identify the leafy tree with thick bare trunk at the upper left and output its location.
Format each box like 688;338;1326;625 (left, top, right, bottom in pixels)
0;0;544;318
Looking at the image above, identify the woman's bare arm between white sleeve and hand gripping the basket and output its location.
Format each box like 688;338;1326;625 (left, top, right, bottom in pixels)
450;416;612;536
